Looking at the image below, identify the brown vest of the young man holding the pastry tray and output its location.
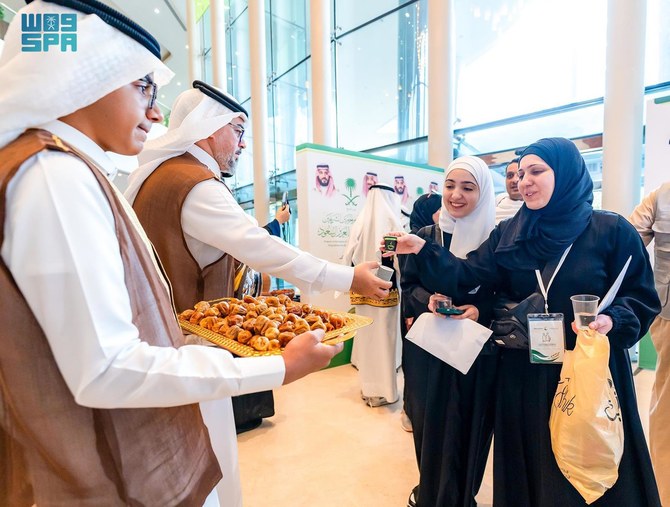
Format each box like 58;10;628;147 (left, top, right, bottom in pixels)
0;130;221;507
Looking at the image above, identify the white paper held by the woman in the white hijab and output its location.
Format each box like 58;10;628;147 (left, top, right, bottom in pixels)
407;313;492;375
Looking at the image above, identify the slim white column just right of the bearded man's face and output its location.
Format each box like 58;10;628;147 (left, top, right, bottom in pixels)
249;0;269;226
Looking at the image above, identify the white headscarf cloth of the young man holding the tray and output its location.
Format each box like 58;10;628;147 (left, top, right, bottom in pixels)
0;0;174;148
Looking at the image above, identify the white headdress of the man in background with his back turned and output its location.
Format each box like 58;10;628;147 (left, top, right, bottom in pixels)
343;185;402;266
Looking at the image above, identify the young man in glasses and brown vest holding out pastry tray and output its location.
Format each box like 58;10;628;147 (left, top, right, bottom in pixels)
0;0;339;507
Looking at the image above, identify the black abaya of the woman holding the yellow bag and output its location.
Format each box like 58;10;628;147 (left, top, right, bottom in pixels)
417;211;660;507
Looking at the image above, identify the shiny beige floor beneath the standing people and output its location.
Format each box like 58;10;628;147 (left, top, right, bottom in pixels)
239;365;654;507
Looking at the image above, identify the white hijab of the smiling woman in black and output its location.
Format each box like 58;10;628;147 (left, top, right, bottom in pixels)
439;156;496;259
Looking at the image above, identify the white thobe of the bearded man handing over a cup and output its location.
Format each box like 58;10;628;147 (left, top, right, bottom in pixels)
166;145;353;507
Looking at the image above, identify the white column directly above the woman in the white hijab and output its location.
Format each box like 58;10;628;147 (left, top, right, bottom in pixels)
428;0;456;170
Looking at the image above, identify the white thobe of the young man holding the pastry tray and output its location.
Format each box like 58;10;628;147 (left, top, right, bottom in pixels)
0;121;285;507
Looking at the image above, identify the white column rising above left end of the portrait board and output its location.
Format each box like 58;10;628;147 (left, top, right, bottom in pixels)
310;0;336;146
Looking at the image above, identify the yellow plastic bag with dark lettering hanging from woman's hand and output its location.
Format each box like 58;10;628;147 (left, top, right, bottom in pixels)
549;330;623;504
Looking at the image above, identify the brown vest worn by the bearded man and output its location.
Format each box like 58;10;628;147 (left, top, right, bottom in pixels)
133;153;235;311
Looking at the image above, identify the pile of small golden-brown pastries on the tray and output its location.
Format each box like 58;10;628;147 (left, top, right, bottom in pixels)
179;294;346;352
